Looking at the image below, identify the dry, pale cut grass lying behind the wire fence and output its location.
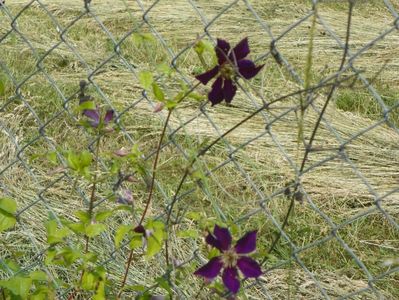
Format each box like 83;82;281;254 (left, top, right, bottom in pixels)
0;0;399;299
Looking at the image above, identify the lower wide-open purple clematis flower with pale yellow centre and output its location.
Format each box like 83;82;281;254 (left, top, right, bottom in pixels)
194;225;262;294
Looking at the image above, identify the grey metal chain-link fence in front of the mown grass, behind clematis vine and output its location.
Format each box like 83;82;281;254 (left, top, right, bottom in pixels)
0;0;399;299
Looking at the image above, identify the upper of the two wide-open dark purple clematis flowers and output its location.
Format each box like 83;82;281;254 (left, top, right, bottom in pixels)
195;38;264;106
